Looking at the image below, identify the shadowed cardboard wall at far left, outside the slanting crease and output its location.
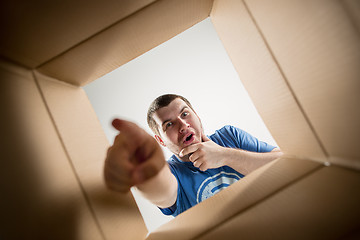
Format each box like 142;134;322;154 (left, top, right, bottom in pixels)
0;62;102;239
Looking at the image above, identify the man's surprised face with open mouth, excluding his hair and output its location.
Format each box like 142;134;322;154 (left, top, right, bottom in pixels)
153;98;203;160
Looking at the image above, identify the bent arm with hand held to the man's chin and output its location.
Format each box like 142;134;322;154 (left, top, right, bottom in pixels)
180;137;283;175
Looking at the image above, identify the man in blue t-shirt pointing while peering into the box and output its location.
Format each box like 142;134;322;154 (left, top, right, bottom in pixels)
104;94;282;216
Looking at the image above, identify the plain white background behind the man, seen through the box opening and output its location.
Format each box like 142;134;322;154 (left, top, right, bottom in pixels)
84;18;276;231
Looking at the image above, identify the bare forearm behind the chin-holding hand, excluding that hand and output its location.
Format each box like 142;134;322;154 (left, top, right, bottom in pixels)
224;149;283;175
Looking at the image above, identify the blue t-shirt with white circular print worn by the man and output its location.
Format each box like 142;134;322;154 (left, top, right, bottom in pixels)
160;125;275;217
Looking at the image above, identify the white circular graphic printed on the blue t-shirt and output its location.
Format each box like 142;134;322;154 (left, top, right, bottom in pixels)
196;171;240;203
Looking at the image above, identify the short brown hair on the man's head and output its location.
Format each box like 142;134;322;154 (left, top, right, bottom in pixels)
147;94;194;135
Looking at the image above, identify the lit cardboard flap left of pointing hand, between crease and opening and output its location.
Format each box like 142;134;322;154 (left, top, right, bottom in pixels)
35;73;146;239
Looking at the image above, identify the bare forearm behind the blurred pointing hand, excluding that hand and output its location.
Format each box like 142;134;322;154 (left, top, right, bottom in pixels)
136;164;177;208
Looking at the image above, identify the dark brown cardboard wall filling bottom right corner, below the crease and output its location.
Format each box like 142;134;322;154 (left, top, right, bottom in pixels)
198;167;360;239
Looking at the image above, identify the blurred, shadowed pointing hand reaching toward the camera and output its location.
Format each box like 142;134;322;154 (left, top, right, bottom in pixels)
104;119;165;193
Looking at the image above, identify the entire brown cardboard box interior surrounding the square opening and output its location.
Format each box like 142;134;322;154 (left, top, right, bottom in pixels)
0;0;360;239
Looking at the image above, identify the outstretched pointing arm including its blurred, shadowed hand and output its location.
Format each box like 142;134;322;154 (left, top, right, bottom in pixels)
104;119;177;208
